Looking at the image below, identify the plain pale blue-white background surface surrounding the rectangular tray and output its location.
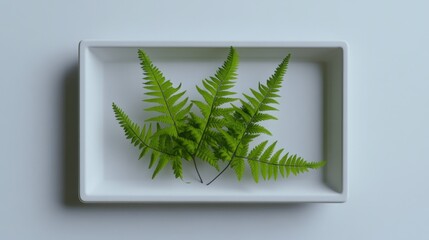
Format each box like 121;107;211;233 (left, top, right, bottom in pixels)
0;0;429;240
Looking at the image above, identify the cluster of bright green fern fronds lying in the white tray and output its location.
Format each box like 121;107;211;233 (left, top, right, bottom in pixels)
113;47;325;185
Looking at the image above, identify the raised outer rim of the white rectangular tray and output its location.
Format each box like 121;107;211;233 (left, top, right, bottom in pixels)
78;39;349;203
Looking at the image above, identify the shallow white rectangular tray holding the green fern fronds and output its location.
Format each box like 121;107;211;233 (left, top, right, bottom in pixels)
79;41;347;202
